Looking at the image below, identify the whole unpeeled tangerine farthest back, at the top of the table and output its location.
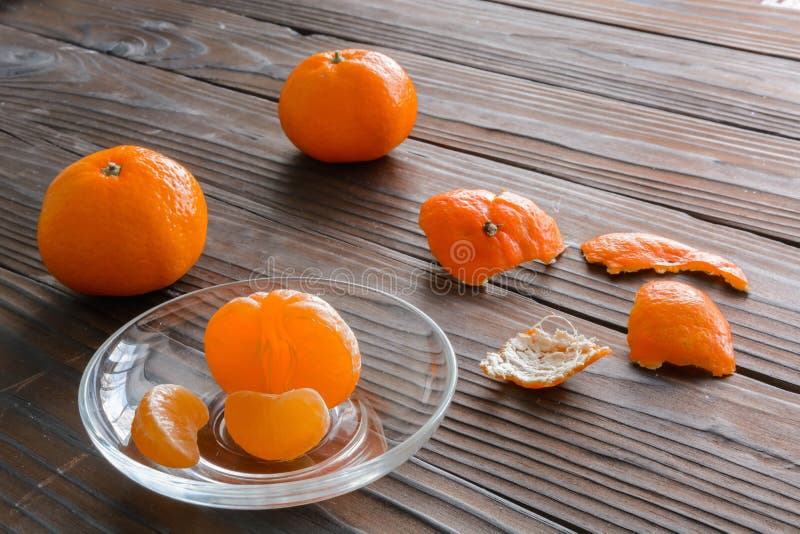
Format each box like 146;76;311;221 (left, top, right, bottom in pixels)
278;49;417;162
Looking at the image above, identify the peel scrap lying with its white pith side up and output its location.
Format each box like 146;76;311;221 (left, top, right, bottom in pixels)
480;316;611;389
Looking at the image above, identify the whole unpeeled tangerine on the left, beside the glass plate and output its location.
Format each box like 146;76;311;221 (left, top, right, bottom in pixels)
37;146;208;295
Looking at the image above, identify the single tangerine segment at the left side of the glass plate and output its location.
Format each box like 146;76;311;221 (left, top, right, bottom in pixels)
131;384;208;468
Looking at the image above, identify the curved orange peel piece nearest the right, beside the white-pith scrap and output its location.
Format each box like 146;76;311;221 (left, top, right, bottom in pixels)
628;280;736;376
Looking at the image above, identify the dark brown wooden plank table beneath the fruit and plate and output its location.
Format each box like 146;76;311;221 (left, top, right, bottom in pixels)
0;0;800;532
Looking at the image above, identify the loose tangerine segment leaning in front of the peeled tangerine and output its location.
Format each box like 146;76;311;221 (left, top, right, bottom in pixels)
225;388;330;460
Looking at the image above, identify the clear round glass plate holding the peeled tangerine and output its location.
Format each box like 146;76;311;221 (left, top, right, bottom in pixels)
78;278;457;509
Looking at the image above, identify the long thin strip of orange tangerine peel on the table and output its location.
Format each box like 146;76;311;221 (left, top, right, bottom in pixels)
581;232;748;291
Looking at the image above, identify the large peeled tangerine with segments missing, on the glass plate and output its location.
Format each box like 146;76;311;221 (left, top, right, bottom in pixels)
205;289;361;408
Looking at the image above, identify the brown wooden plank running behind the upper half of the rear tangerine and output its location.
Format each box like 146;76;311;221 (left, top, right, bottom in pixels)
0;0;800;244
